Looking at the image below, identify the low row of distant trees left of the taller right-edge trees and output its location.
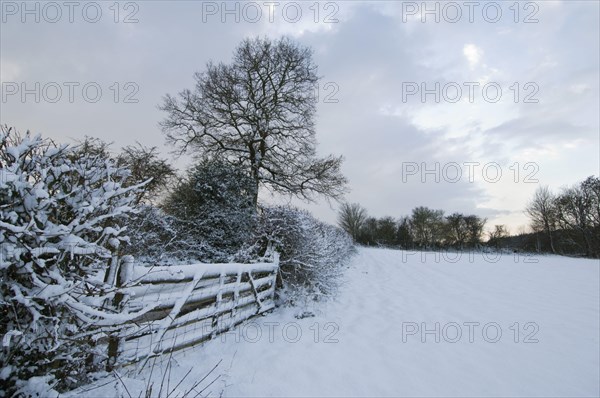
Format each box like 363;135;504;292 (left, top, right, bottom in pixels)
338;203;488;250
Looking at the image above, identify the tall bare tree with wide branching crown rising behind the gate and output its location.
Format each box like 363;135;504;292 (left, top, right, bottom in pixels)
161;38;346;203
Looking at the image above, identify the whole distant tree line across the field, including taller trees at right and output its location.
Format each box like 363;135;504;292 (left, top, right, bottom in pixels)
338;176;600;258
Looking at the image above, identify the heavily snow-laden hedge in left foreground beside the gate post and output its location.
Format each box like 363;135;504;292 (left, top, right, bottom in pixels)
0;127;142;396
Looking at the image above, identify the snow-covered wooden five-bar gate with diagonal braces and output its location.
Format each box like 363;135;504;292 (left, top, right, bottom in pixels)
108;253;279;369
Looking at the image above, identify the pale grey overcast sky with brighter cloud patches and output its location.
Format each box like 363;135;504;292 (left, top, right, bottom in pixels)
0;1;600;233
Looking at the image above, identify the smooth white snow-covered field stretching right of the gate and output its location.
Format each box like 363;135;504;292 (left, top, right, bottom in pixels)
74;248;600;397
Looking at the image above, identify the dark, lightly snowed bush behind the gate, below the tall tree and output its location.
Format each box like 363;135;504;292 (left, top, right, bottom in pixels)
141;158;256;263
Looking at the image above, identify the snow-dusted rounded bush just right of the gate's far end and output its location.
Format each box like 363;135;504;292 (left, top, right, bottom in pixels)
258;206;354;302
